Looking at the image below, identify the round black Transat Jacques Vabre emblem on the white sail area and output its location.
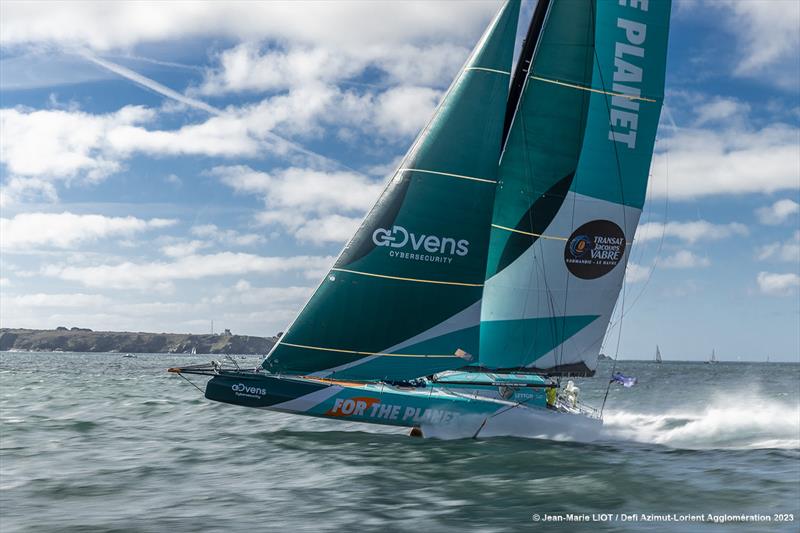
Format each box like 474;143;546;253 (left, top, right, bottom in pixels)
564;220;625;279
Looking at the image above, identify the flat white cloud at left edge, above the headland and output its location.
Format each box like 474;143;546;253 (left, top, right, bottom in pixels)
0;211;177;250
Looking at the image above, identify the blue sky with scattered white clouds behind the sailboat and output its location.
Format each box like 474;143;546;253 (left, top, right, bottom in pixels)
0;0;800;362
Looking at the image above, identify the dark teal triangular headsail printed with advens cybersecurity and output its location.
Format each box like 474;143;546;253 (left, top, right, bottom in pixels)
263;0;519;380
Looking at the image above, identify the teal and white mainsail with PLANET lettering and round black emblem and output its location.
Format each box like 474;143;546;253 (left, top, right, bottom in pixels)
480;0;670;373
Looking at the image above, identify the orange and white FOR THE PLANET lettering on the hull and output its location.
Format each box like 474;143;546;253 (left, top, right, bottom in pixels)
325;396;458;424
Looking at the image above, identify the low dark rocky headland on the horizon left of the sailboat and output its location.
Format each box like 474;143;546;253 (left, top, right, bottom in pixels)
0;327;280;355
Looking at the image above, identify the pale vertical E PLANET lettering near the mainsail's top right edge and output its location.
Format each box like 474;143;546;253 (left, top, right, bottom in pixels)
608;0;648;150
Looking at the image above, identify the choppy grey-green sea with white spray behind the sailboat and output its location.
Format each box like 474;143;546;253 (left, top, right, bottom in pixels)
0;352;800;533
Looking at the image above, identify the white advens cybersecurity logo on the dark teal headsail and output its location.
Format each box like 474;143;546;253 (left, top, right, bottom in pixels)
372;226;469;263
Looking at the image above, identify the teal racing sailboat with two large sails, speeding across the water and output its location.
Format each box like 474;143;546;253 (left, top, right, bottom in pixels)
170;0;670;437
